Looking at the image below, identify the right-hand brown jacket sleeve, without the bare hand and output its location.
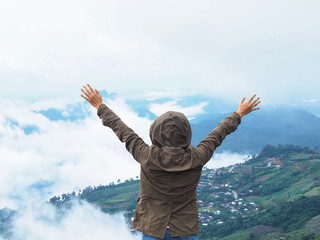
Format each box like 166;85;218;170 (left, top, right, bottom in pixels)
196;112;241;165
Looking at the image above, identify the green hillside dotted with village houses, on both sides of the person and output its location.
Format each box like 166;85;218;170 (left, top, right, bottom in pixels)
50;145;320;240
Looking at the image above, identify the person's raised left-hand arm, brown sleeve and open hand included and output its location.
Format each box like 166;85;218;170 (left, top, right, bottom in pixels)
81;84;149;162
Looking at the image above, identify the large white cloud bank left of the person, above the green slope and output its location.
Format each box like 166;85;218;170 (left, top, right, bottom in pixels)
0;96;150;208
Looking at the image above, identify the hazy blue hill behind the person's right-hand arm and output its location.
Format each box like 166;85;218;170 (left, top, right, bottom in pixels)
192;107;320;154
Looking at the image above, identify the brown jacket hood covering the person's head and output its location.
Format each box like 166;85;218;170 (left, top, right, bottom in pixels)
150;111;192;148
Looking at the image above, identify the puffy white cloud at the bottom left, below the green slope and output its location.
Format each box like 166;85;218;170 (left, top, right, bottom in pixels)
13;202;141;240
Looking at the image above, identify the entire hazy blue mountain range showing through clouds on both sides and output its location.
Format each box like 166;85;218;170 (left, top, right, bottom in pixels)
33;90;320;154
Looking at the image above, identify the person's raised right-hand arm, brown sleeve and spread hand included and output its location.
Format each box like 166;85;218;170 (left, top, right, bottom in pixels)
196;95;261;165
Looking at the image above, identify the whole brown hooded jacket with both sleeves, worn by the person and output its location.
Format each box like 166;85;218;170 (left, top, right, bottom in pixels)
98;104;241;239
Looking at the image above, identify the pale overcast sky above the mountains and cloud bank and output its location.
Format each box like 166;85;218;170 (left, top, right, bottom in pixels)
0;0;320;103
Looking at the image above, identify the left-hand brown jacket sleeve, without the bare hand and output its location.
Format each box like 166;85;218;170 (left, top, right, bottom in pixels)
97;104;149;163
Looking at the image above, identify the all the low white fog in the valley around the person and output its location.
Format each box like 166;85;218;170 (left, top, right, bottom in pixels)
0;97;246;240
